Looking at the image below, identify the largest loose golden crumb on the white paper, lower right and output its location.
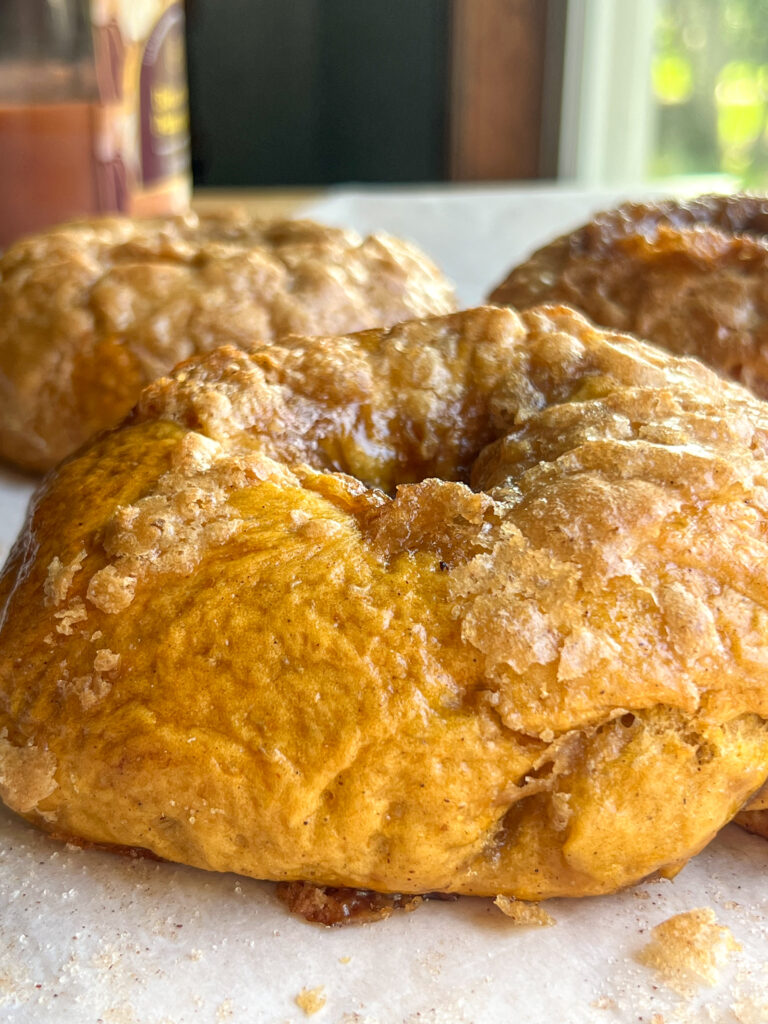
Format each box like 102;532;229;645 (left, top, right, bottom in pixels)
637;906;741;995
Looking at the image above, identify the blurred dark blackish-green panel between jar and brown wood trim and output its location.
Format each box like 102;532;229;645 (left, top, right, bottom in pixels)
186;0;450;186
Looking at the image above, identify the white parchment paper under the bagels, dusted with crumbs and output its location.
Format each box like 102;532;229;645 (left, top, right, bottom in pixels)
0;188;768;1024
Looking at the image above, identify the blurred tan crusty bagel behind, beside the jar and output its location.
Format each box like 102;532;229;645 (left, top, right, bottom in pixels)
0;213;456;470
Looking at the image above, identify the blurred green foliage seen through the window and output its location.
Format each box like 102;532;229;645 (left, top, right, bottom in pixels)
649;0;768;188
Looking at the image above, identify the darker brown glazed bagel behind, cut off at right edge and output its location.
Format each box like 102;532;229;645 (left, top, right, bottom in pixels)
489;195;768;398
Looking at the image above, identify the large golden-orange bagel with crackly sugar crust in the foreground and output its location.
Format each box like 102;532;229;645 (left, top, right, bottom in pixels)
0;307;768;899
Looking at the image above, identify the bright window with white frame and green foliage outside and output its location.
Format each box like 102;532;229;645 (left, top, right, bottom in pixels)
559;0;768;188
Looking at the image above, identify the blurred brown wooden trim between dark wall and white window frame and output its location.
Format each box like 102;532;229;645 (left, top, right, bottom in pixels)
449;0;566;181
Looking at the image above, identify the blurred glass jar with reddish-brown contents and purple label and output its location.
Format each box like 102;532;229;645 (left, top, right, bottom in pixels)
0;0;190;247
